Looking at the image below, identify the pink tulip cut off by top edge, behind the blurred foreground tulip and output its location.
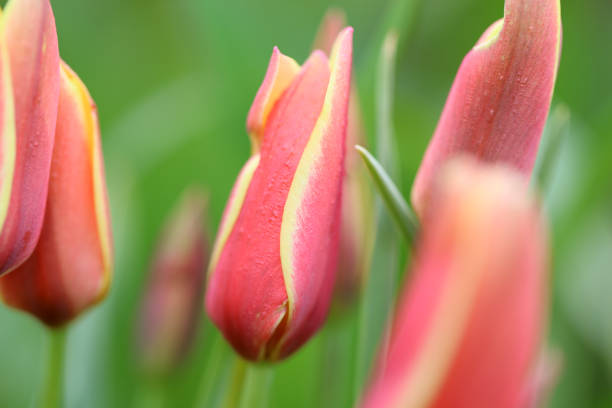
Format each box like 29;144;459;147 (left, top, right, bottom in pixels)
412;0;561;215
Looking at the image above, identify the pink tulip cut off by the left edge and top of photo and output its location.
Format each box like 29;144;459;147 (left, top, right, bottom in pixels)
0;0;60;275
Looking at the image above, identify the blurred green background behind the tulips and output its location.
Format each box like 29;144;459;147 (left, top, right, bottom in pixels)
0;0;612;408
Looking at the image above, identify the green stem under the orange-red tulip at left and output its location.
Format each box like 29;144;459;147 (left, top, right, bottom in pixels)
41;328;66;408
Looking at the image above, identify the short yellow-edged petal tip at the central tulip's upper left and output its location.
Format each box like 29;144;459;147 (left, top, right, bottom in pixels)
247;47;300;152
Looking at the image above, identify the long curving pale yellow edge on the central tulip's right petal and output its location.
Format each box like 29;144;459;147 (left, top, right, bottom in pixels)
278;28;353;326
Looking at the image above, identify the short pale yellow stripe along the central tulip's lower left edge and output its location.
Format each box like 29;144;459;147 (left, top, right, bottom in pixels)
208;154;259;279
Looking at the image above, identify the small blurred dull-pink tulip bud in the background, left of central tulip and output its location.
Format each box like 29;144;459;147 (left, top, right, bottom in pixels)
138;189;209;373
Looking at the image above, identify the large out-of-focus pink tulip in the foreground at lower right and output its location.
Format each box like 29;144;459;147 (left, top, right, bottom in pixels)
363;158;548;408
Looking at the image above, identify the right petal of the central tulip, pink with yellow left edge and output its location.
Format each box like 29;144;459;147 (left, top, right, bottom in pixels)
276;28;353;353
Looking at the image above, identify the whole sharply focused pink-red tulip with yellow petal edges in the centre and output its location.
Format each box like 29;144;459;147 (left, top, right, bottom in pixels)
206;28;352;361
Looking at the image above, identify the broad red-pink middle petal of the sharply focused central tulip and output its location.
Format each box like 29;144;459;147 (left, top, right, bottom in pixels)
206;52;329;360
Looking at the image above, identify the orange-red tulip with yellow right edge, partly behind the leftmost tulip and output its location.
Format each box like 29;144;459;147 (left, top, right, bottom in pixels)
0;62;112;326
